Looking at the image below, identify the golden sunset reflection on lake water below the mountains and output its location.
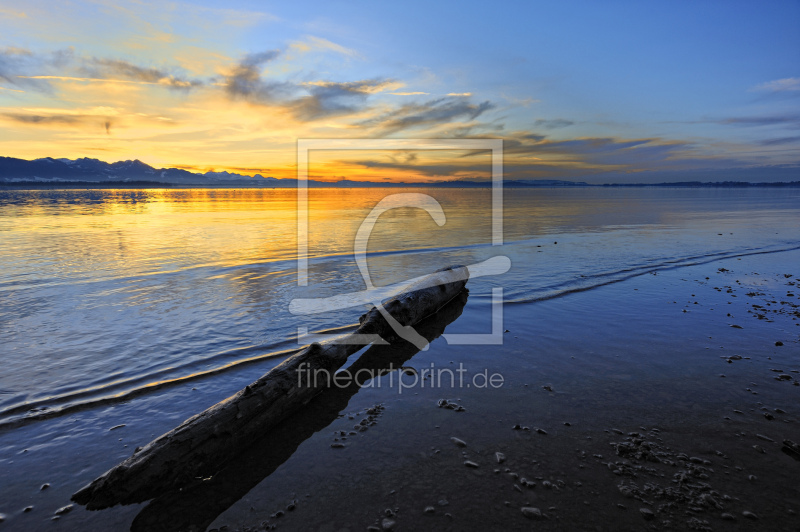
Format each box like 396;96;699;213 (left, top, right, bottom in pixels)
0;189;504;282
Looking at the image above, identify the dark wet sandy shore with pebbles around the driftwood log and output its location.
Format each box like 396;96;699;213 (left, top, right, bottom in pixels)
0;247;800;531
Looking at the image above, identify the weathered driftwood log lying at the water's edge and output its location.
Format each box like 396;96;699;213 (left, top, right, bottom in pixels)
72;266;469;510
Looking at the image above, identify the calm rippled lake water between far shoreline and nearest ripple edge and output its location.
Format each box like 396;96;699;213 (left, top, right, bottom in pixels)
0;188;800;422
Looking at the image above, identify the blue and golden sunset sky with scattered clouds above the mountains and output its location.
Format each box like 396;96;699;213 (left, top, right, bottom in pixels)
0;0;800;183
